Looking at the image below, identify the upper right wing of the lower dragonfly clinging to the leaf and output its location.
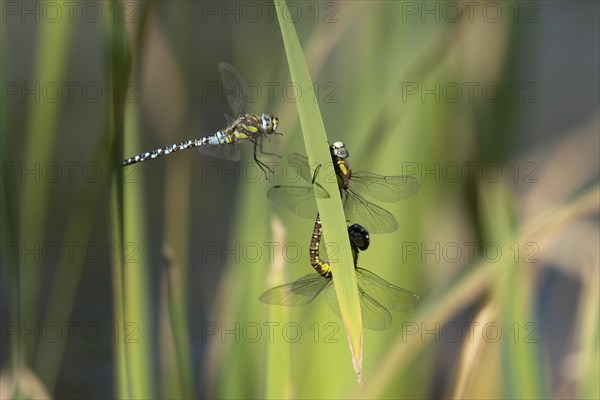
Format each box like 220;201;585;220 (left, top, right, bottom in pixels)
356;268;422;312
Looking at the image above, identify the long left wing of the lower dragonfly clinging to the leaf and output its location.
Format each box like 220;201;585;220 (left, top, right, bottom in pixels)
260;273;331;306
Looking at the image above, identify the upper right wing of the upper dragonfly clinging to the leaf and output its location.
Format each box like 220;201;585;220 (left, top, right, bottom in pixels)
350;172;421;203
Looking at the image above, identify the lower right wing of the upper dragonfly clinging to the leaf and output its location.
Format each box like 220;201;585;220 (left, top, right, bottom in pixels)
342;188;400;233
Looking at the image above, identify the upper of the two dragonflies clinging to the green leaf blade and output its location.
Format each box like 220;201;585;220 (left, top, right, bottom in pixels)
267;142;421;233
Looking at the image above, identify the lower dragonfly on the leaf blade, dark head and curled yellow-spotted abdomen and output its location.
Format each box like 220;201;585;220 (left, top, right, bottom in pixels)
260;216;422;330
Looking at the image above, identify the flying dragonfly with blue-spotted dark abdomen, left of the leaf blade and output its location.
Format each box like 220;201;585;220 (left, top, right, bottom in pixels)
122;63;281;175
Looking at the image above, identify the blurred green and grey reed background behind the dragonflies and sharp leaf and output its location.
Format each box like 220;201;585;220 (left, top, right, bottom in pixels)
0;1;600;398
